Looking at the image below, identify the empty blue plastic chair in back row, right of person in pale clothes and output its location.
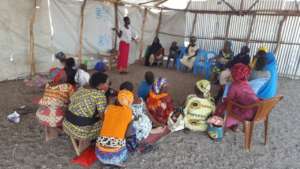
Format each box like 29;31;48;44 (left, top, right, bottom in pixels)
193;50;216;80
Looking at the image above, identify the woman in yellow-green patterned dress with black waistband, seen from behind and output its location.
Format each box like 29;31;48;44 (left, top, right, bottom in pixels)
63;72;109;151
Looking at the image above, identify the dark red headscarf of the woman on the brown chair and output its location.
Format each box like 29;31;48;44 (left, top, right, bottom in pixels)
231;63;251;82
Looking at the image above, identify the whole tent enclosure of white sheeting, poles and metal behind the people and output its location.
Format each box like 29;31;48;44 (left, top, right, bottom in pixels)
0;0;300;81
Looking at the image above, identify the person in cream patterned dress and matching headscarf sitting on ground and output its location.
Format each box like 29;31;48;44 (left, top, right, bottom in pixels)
183;80;215;131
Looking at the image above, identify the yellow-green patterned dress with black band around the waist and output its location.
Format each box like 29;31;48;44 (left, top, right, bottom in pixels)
63;88;107;140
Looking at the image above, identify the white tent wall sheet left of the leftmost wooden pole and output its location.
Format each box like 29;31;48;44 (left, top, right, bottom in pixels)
0;0;34;81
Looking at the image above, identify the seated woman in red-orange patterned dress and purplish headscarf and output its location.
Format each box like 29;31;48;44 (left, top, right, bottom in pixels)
147;77;174;127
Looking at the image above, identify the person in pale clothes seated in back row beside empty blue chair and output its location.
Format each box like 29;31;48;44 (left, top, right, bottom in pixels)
180;36;197;70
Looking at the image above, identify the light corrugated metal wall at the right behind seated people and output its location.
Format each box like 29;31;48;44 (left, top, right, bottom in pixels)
185;0;300;79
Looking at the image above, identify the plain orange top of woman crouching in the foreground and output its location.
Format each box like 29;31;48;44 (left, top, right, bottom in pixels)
100;105;132;139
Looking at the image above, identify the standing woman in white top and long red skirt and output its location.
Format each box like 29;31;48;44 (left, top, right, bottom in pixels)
116;16;135;74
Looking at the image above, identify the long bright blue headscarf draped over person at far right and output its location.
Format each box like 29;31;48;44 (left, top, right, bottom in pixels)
257;52;278;99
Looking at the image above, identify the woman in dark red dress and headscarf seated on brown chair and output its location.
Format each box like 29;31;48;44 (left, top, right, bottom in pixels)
215;63;259;130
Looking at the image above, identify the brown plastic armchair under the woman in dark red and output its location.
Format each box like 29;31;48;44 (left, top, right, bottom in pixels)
224;96;283;151
